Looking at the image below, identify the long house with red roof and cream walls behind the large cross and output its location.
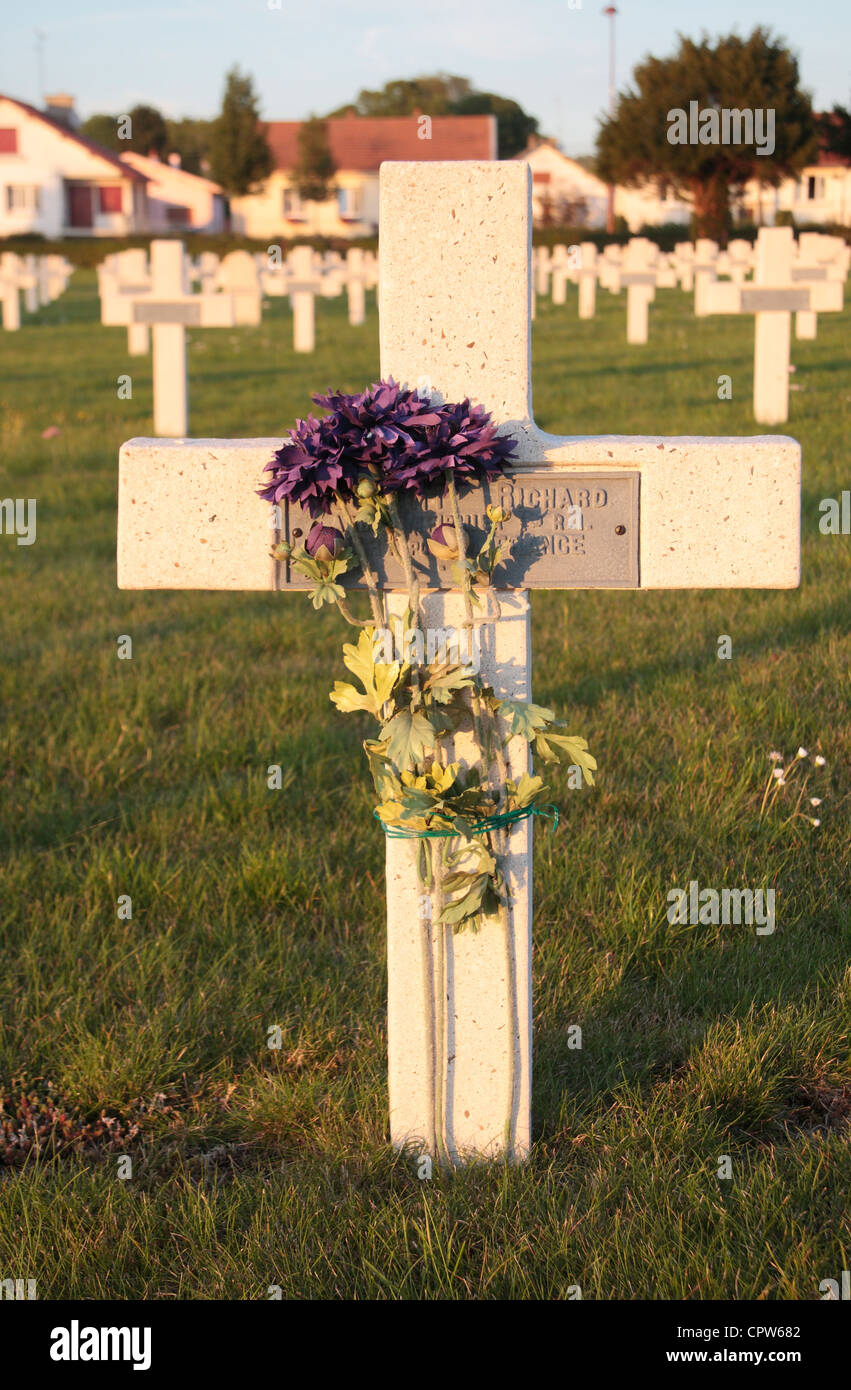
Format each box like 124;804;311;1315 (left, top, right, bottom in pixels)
231;113;496;238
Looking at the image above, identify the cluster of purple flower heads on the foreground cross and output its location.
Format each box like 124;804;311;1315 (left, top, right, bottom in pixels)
260;378;514;518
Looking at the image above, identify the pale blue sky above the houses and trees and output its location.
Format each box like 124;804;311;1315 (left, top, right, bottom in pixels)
0;0;851;154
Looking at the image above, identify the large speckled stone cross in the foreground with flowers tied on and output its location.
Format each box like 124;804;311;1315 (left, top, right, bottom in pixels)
118;160;801;1161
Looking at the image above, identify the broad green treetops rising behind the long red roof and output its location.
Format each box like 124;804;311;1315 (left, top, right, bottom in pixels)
325;72;538;160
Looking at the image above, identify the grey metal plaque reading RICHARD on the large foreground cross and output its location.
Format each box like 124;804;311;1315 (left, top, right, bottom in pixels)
275;467;640;589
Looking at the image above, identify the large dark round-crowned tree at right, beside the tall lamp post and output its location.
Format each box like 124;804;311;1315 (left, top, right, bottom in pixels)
597;28;816;242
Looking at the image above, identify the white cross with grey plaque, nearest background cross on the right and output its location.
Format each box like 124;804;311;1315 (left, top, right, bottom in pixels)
695;227;843;425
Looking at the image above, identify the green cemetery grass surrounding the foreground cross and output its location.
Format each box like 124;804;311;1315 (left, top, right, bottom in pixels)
0;271;851;1300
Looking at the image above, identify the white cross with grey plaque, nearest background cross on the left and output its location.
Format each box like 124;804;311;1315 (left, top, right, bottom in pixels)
102;242;236;435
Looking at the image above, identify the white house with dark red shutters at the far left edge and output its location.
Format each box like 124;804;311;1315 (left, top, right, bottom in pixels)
0;95;146;238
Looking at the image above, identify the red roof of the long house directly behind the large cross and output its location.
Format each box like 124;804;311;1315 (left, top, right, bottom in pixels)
263;114;496;174
